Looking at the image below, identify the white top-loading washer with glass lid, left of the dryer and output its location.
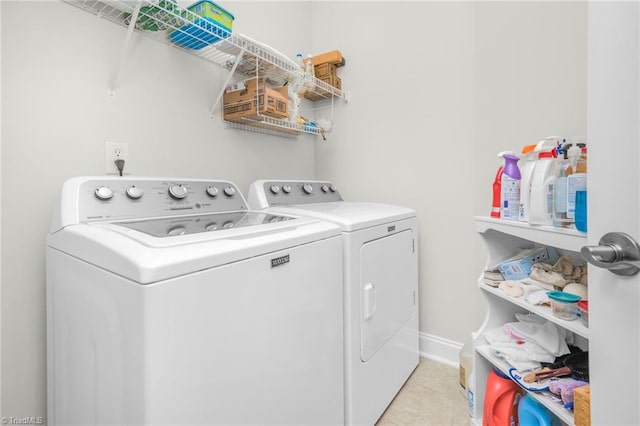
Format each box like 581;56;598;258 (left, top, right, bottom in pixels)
47;177;344;425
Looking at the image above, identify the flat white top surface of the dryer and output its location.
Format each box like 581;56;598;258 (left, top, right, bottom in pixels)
266;201;416;232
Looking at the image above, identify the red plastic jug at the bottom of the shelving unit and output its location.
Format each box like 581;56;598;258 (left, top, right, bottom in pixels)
482;369;524;426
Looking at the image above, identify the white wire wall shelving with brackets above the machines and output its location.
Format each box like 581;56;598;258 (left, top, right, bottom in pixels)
65;0;348;137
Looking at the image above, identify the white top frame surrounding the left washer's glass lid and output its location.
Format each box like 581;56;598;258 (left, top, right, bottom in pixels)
47;212;340;284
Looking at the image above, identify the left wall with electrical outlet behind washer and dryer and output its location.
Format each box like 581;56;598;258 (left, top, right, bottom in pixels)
0;1;314;417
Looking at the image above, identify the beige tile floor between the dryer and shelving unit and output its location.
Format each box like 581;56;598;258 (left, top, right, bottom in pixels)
376;358;471;426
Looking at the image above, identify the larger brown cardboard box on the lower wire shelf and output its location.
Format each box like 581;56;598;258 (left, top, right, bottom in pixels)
223;78;289;121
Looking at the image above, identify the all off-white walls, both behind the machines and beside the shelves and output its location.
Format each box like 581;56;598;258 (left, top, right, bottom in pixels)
0;1;586;416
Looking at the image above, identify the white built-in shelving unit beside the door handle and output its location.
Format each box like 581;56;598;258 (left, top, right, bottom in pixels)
473;216;589;425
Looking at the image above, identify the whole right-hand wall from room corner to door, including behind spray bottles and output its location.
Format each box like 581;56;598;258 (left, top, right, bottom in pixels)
313;2;586;350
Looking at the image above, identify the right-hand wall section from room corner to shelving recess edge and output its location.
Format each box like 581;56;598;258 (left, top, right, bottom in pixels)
313;2;478;360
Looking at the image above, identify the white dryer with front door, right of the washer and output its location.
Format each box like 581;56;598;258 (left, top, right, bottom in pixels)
248;180;419;425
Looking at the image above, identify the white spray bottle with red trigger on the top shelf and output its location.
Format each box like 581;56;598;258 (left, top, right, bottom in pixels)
529;148;558;225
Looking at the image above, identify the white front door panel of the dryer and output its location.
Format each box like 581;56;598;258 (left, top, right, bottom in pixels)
360;230;417;362
